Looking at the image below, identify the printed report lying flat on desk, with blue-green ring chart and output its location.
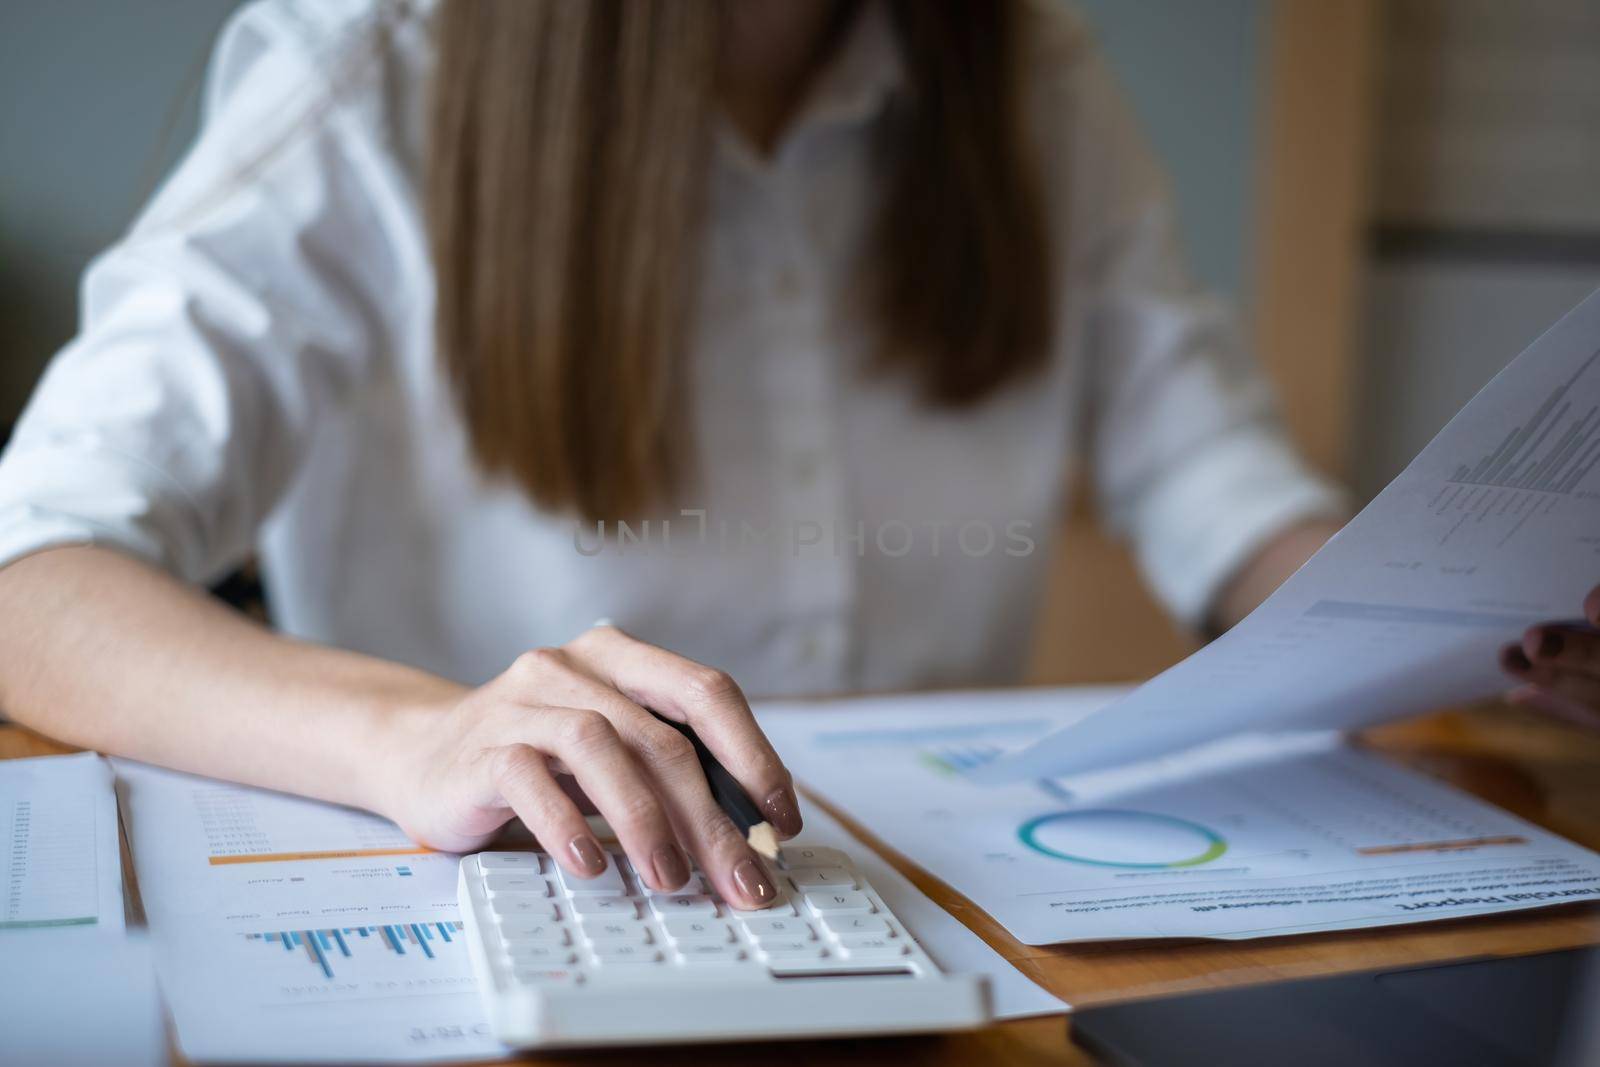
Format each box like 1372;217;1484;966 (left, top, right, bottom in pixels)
757;689;1600;945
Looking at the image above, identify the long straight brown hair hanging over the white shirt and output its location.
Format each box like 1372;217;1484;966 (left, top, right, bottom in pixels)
427;0;1053;518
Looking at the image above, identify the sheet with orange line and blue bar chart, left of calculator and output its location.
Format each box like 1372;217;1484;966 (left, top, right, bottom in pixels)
115;760;506;1062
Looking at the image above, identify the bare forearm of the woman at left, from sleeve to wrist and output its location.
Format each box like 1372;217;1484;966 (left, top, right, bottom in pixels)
0;547;464;808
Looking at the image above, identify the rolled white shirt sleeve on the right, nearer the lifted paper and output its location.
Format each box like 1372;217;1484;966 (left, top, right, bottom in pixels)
1075;58;1347;625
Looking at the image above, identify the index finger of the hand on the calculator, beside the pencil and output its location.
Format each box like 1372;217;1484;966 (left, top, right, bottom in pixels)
568;625;802;838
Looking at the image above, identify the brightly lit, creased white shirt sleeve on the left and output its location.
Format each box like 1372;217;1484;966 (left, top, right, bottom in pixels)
0;5;395;581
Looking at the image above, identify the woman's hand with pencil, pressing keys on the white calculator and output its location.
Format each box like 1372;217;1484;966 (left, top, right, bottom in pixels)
382;625;800;907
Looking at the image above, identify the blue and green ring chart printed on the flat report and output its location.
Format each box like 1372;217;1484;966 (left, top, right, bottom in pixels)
1016;808;1227;870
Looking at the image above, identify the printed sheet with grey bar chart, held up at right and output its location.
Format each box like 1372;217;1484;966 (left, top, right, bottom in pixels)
974;293;1600;781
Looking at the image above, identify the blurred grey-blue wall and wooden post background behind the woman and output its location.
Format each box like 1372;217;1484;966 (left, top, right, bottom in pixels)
0;0;1600;681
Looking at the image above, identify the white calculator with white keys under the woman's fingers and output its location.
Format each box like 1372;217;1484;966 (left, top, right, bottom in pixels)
459;845;990;1048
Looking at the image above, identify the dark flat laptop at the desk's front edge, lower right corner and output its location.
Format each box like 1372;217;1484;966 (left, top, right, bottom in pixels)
1070;949;1600;1067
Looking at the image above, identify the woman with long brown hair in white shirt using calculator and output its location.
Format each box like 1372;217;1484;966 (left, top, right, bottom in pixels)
0;0;1595;907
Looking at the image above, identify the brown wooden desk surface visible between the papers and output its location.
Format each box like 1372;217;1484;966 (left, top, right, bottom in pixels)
0;707;1600;1067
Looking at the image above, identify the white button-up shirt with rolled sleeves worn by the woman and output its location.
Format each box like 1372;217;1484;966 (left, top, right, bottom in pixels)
0;0;1339;694
